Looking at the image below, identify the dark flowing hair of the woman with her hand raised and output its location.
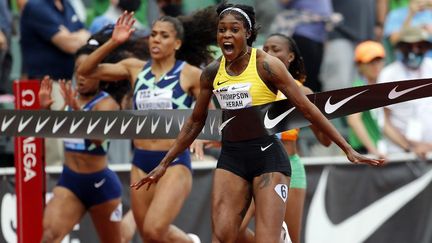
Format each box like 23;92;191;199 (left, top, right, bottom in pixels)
157;6;218;67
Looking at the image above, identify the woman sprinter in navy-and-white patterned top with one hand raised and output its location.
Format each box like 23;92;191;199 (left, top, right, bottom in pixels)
78;8;218;243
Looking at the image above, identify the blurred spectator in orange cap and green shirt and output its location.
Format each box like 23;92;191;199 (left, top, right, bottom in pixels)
347;41;385;158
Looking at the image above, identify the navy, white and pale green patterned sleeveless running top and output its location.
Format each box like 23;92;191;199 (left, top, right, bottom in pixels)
133;60;194;110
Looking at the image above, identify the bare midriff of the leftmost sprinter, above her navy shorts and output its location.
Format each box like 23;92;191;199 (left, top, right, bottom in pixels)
64;151;107;173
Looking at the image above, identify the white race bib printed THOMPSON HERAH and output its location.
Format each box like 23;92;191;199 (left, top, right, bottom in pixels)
213;83;252;110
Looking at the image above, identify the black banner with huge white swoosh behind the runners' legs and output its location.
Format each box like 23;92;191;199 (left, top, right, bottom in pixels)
0;161;432;243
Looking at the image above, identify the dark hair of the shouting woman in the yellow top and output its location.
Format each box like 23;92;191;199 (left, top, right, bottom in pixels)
216;1;259;46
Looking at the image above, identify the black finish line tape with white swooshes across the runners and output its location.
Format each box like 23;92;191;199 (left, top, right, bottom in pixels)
0;79;432;141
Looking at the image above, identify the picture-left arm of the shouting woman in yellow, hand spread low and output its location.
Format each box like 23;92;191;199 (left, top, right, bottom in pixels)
131;61;219;189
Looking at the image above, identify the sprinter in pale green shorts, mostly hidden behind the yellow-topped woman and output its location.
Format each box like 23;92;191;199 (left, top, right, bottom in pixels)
237;34;331;243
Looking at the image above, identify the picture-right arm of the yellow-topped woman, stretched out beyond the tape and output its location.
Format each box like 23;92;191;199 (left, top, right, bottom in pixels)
257;52;384;165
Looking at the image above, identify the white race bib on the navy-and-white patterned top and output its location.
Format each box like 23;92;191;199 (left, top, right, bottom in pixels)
135;89;173;110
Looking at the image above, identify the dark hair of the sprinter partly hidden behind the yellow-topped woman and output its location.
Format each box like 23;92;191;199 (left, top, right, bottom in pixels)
267;33;306;83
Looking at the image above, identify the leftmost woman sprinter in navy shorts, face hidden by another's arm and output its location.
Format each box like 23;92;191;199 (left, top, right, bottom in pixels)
39;44;122;243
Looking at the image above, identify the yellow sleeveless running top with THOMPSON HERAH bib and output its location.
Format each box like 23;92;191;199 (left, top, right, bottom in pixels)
213;48;276;109
